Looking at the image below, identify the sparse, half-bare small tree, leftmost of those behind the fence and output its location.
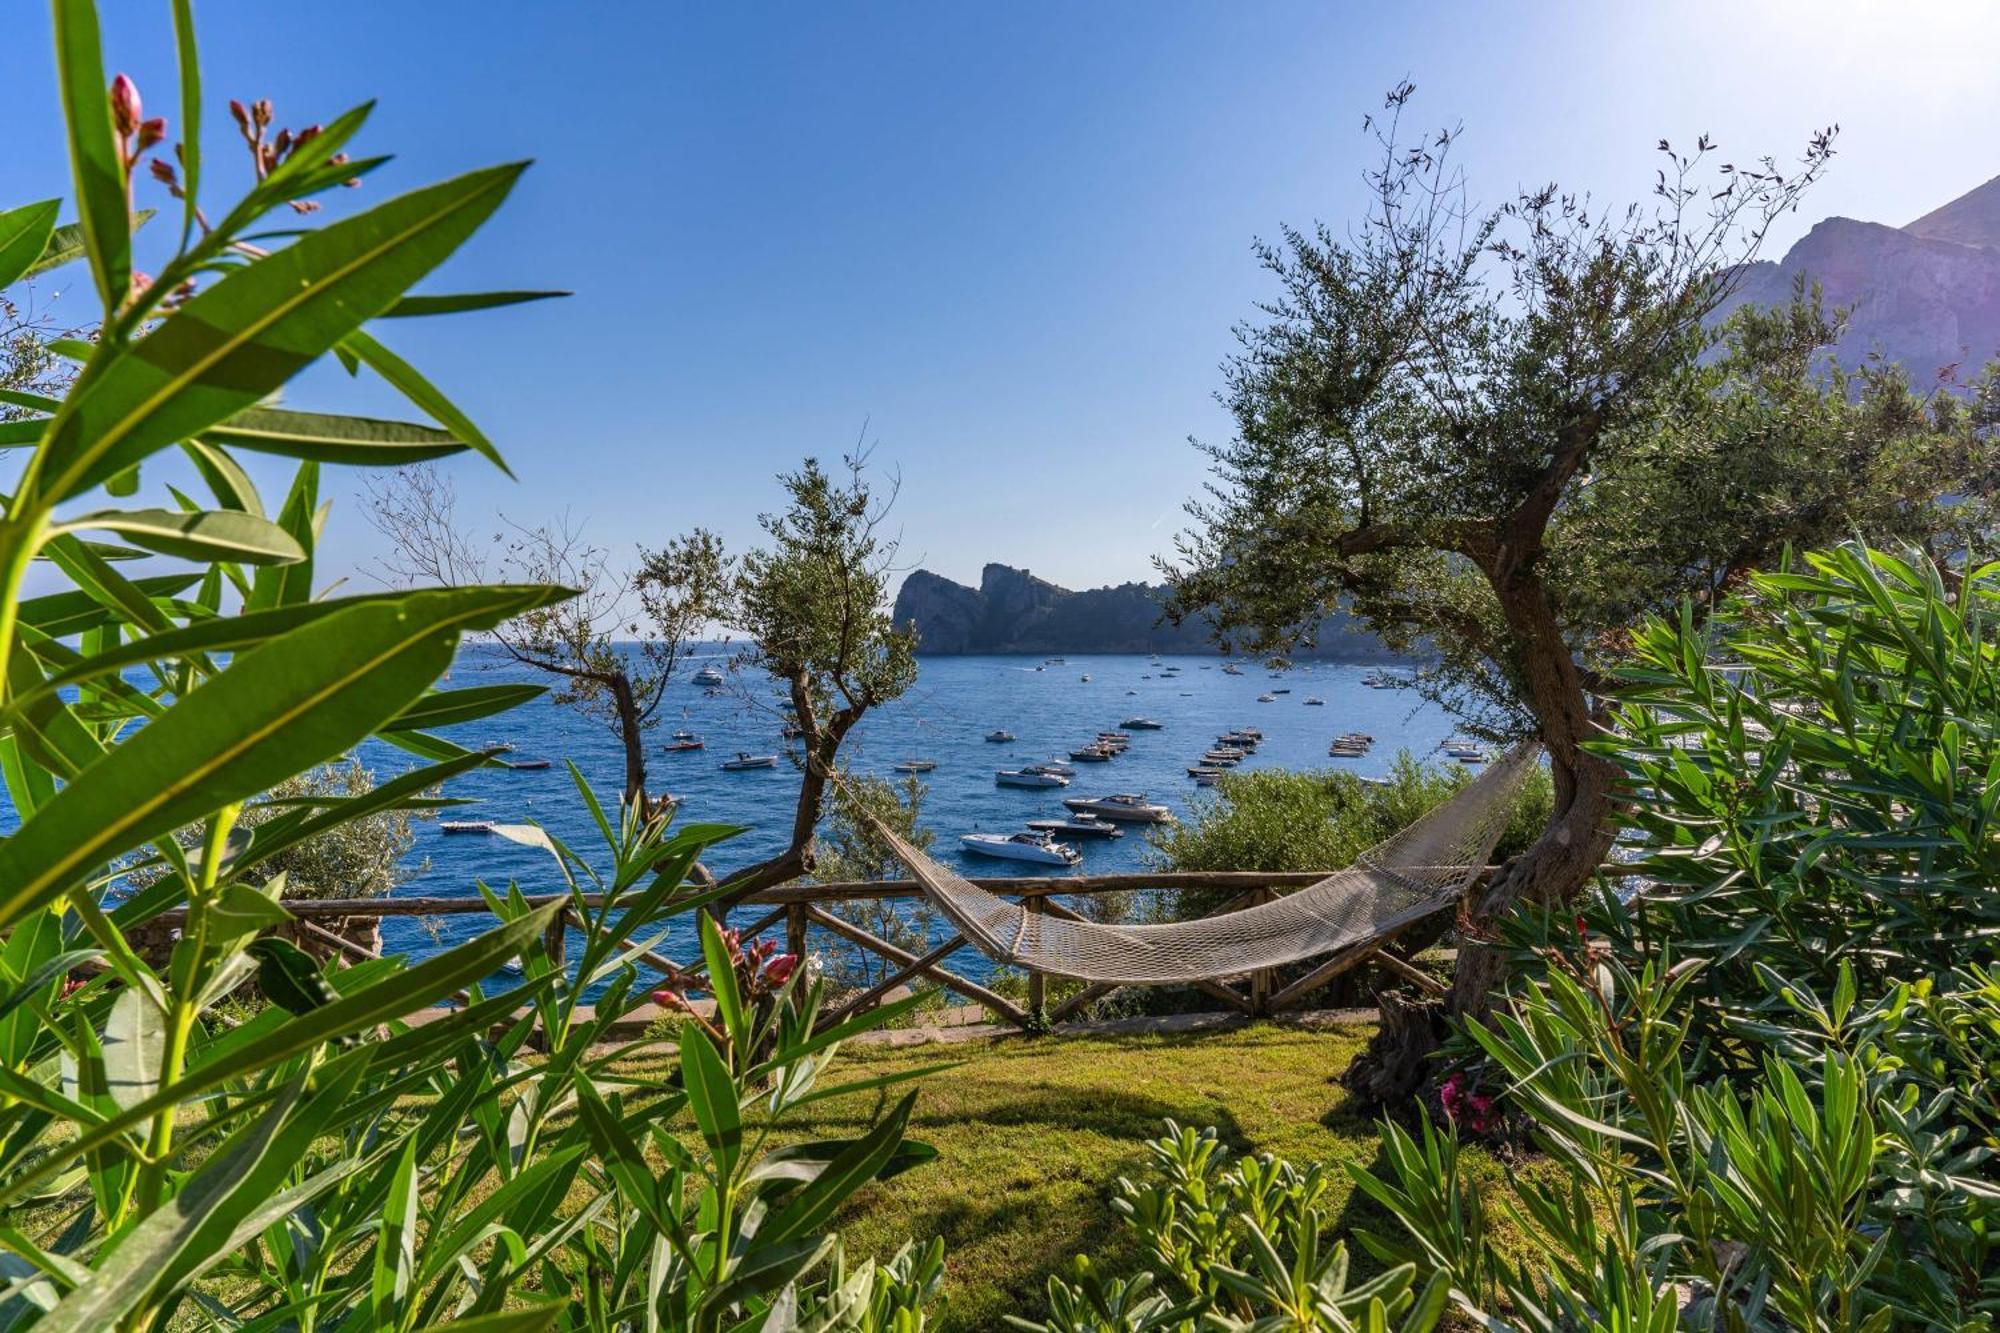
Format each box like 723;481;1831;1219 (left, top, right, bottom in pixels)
366;464;732;805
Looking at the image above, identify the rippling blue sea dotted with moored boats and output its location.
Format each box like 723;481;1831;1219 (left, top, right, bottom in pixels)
362;644;1456;975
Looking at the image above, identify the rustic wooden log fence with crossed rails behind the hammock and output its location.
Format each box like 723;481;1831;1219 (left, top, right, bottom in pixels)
160;871;1484;1031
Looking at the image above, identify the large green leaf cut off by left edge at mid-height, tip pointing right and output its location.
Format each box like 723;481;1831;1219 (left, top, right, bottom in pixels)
0;586;568;925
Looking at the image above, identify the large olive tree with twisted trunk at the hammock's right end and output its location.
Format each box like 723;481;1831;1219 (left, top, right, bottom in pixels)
1162;84;1988;1013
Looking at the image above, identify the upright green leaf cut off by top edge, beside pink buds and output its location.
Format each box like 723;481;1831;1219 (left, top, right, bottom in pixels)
54;0;132;316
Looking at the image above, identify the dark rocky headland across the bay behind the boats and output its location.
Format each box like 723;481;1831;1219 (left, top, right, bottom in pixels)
896;564;1392;662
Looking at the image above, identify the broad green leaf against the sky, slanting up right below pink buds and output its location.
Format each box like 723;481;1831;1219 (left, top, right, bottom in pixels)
38;162;522;500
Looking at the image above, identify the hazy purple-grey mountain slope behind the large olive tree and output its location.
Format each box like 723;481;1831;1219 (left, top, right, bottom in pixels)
1730;178;2000;378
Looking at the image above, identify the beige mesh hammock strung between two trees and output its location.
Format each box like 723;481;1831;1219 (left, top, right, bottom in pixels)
868;743;1540;985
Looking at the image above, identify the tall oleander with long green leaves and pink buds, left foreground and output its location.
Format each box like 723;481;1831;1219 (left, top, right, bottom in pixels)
0;0;942;1333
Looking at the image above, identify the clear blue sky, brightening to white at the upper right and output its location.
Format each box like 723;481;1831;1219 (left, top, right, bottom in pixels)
0;0;2000;586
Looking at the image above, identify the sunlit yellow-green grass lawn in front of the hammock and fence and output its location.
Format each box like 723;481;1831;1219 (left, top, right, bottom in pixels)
768;1023;1502;1329
